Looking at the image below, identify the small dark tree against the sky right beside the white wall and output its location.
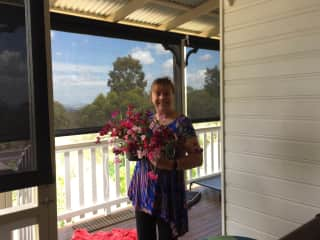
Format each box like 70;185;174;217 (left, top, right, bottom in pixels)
204;65;220;96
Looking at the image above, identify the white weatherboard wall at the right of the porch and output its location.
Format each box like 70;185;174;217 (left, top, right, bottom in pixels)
221;0;320;240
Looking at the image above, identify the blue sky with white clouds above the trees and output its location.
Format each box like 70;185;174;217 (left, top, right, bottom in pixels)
51;31;219;108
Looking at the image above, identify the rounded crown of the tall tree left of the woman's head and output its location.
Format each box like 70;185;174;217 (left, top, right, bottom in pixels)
108;55;147;93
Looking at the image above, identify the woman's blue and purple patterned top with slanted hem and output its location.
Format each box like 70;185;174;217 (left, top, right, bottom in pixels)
128;115;196;237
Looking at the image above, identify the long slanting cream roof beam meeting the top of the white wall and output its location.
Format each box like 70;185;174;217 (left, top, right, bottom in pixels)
158;0;219;31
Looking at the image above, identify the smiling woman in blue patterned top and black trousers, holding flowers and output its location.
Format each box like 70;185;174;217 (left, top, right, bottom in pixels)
128;78;202;240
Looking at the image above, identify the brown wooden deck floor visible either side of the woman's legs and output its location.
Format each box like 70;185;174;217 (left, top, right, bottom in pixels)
102;188;221;240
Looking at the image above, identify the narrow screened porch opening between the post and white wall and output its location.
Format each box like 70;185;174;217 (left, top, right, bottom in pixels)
186;48;220;122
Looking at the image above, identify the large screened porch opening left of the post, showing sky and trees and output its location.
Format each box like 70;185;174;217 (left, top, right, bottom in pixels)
51;31;173;135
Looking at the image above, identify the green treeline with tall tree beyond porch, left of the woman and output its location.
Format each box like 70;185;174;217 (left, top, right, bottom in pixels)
54;55;151;129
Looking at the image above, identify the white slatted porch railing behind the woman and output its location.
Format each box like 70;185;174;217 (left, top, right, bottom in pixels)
10;124;221;240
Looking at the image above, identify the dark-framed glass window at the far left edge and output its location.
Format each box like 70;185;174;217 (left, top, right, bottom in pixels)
0;0;53;191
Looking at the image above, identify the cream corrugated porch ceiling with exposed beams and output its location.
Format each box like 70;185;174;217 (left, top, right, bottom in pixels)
49;0;219;38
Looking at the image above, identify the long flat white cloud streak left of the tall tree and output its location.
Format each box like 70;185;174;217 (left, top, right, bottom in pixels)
52;62;111;75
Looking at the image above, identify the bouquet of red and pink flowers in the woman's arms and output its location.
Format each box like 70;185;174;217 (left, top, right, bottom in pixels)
96;105;177;180
